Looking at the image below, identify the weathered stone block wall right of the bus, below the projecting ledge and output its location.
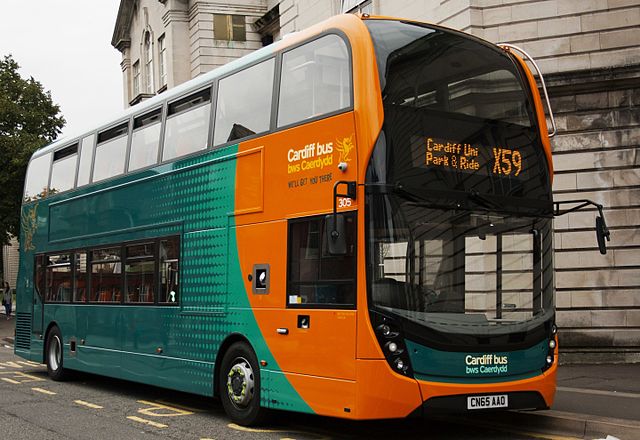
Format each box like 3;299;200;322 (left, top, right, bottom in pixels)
547;66;640;361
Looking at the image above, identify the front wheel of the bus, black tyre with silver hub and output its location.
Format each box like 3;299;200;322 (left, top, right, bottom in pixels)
218;342;267;426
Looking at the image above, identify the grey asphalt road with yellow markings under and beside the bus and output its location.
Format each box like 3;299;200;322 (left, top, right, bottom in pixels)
0;344;546;440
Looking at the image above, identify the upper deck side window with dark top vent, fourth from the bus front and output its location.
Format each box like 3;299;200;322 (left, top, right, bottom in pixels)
129;108;162;171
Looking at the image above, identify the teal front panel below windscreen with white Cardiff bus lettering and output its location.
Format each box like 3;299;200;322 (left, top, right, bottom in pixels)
406;340;549;383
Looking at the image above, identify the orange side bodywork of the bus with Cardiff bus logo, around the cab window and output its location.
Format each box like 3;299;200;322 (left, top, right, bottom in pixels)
230;112;358;417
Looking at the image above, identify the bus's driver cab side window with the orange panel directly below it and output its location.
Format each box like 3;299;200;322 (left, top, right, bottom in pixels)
278;211;357;380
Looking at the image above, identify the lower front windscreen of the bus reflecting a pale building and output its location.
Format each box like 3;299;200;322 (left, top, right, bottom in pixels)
371;208;551;325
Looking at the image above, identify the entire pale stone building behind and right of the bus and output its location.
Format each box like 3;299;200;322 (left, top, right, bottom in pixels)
112;0;640;361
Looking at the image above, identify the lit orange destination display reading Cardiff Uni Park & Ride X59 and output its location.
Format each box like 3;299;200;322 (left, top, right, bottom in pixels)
424;137;526;177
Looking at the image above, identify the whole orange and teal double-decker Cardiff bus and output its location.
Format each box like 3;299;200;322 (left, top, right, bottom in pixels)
15;15;606;424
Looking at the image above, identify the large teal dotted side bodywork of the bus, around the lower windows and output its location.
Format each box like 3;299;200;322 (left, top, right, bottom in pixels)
19;145;312;412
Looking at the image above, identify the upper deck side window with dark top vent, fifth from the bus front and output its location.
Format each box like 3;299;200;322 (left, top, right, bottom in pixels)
93;122;129;182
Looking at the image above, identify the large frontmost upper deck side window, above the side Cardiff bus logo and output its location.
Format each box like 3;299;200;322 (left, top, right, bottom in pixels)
278;35;351;127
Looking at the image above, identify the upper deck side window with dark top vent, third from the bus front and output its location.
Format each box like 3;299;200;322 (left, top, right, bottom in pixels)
162;88;211;161
